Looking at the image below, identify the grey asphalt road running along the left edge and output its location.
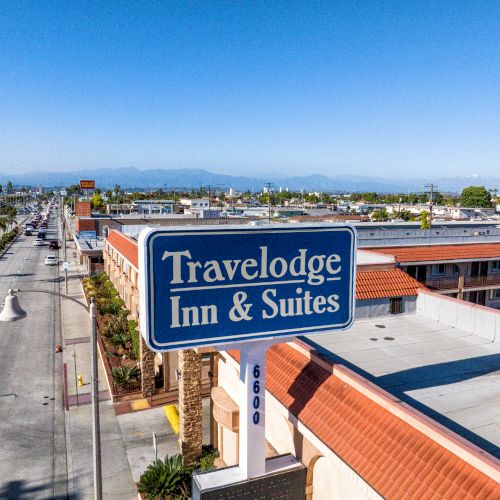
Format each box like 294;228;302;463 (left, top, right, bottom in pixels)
0;205;67;499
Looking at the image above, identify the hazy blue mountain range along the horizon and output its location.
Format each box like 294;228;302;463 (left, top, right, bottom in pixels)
0;167;500;193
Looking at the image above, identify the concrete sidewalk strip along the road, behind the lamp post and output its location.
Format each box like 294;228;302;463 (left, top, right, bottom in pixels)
60;241;137;499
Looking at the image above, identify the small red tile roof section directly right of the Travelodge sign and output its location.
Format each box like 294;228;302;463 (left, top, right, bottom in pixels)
356;269;423;300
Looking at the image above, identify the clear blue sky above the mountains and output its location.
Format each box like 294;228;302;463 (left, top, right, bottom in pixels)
0;0;500;178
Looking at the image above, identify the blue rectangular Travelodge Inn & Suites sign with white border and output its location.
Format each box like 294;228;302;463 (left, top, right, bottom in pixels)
139;224;356;351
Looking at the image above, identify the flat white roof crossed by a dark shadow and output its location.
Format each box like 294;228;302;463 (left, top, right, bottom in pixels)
305;314;500;458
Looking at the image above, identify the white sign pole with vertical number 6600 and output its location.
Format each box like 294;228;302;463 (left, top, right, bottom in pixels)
239;340;276;479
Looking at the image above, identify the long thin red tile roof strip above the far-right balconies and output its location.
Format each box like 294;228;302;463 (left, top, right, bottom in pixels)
369;243;500;262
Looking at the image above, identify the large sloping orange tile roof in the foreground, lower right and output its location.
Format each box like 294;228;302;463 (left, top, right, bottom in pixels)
230;344;500;499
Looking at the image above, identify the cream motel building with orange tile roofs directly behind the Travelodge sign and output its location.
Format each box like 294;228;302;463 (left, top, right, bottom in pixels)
104;231;500;500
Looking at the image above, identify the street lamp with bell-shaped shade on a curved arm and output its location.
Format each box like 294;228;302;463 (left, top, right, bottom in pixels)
0;288;102;500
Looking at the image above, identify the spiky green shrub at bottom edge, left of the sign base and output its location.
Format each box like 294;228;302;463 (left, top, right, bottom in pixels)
138;455;192;500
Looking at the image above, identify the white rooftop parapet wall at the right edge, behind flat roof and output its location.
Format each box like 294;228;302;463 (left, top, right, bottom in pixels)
417;290;500;343
